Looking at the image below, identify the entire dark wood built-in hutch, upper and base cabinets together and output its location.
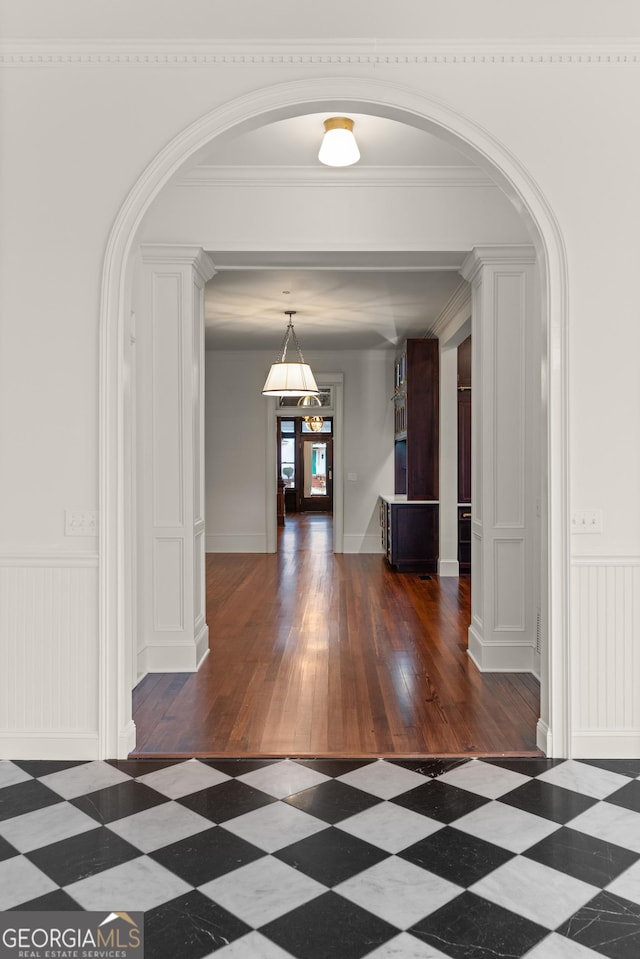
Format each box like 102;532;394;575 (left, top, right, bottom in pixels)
380;339;440;573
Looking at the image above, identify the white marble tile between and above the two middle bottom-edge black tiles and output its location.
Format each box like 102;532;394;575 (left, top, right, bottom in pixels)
334;856;464;929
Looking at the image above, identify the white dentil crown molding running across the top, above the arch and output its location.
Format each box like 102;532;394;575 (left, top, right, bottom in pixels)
0;37;640;66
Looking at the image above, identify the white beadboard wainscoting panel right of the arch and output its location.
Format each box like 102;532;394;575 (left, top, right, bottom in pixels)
571;556;640;758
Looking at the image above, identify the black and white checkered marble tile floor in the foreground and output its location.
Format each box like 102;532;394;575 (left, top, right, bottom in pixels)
0;759;640;959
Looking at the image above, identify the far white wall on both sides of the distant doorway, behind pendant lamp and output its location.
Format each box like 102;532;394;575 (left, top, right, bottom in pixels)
205;350;394;553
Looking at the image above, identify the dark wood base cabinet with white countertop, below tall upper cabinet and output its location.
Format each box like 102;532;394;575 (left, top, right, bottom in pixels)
380;499;438;573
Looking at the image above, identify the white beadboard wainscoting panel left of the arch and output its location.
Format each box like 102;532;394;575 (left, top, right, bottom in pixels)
0;551;98;759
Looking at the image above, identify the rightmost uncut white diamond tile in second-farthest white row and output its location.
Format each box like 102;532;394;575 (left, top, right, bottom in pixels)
454;800;560;852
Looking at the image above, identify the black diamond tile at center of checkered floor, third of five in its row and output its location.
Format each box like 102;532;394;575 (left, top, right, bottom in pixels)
274;828;389;886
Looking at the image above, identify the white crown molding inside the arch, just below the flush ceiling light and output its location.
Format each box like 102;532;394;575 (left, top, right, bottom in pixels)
177;165;497;189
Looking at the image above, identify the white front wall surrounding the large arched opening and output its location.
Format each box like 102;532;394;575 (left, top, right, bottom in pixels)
0;0;640;758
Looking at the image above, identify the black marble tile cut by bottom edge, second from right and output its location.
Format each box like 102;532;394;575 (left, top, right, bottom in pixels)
409;892;549;959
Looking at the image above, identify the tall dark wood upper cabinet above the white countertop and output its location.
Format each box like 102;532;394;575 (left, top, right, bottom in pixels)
394;339;440;500
